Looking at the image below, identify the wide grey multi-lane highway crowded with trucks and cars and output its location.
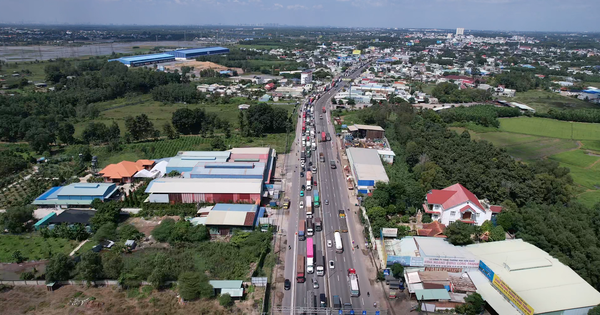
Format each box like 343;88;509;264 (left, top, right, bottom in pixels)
282;59;385;314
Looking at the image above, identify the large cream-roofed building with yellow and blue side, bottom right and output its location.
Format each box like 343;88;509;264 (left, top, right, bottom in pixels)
466;239;600;315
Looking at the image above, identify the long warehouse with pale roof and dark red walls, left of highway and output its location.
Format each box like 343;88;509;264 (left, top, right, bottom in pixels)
145;177;263;204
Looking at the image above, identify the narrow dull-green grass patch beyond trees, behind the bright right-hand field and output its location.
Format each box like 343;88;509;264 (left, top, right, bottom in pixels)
510;90;598;112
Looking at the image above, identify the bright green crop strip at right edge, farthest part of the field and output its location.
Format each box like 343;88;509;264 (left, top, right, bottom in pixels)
500;117;600;140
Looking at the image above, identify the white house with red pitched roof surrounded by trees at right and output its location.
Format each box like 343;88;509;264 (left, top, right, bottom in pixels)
423;183;502;226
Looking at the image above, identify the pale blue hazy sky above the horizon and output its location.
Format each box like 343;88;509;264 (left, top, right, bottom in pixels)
0;0;600;32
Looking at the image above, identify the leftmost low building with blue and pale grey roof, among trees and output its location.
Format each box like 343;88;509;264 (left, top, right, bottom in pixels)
32;183;118;208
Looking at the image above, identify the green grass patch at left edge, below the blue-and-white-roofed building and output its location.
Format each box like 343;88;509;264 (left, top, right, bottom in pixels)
0;234;78;262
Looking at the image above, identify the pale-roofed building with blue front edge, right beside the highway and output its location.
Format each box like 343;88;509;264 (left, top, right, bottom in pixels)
346;148;389;194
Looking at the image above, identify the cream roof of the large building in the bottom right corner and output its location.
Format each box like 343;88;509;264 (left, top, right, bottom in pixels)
466;239;600;314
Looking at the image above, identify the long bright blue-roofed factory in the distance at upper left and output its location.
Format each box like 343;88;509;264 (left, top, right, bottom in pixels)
108;47;229;67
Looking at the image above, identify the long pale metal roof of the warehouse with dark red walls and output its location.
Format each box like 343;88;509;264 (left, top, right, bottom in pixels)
146;178;263;194
